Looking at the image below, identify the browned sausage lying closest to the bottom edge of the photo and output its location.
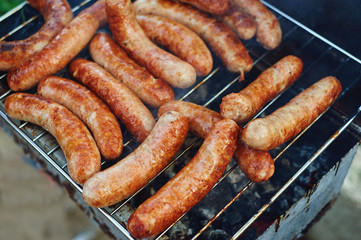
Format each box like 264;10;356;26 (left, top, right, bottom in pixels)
127;119;238;238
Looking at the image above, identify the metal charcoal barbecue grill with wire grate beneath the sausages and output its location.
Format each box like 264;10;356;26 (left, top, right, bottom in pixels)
0;0;361;239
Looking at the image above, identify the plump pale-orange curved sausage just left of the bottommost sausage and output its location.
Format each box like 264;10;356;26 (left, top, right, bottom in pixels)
83;112;188;207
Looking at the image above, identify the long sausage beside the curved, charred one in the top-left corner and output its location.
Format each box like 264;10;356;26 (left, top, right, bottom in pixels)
7;1;106;91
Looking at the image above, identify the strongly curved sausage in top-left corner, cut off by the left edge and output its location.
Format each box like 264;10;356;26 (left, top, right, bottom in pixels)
0;0;73;71
